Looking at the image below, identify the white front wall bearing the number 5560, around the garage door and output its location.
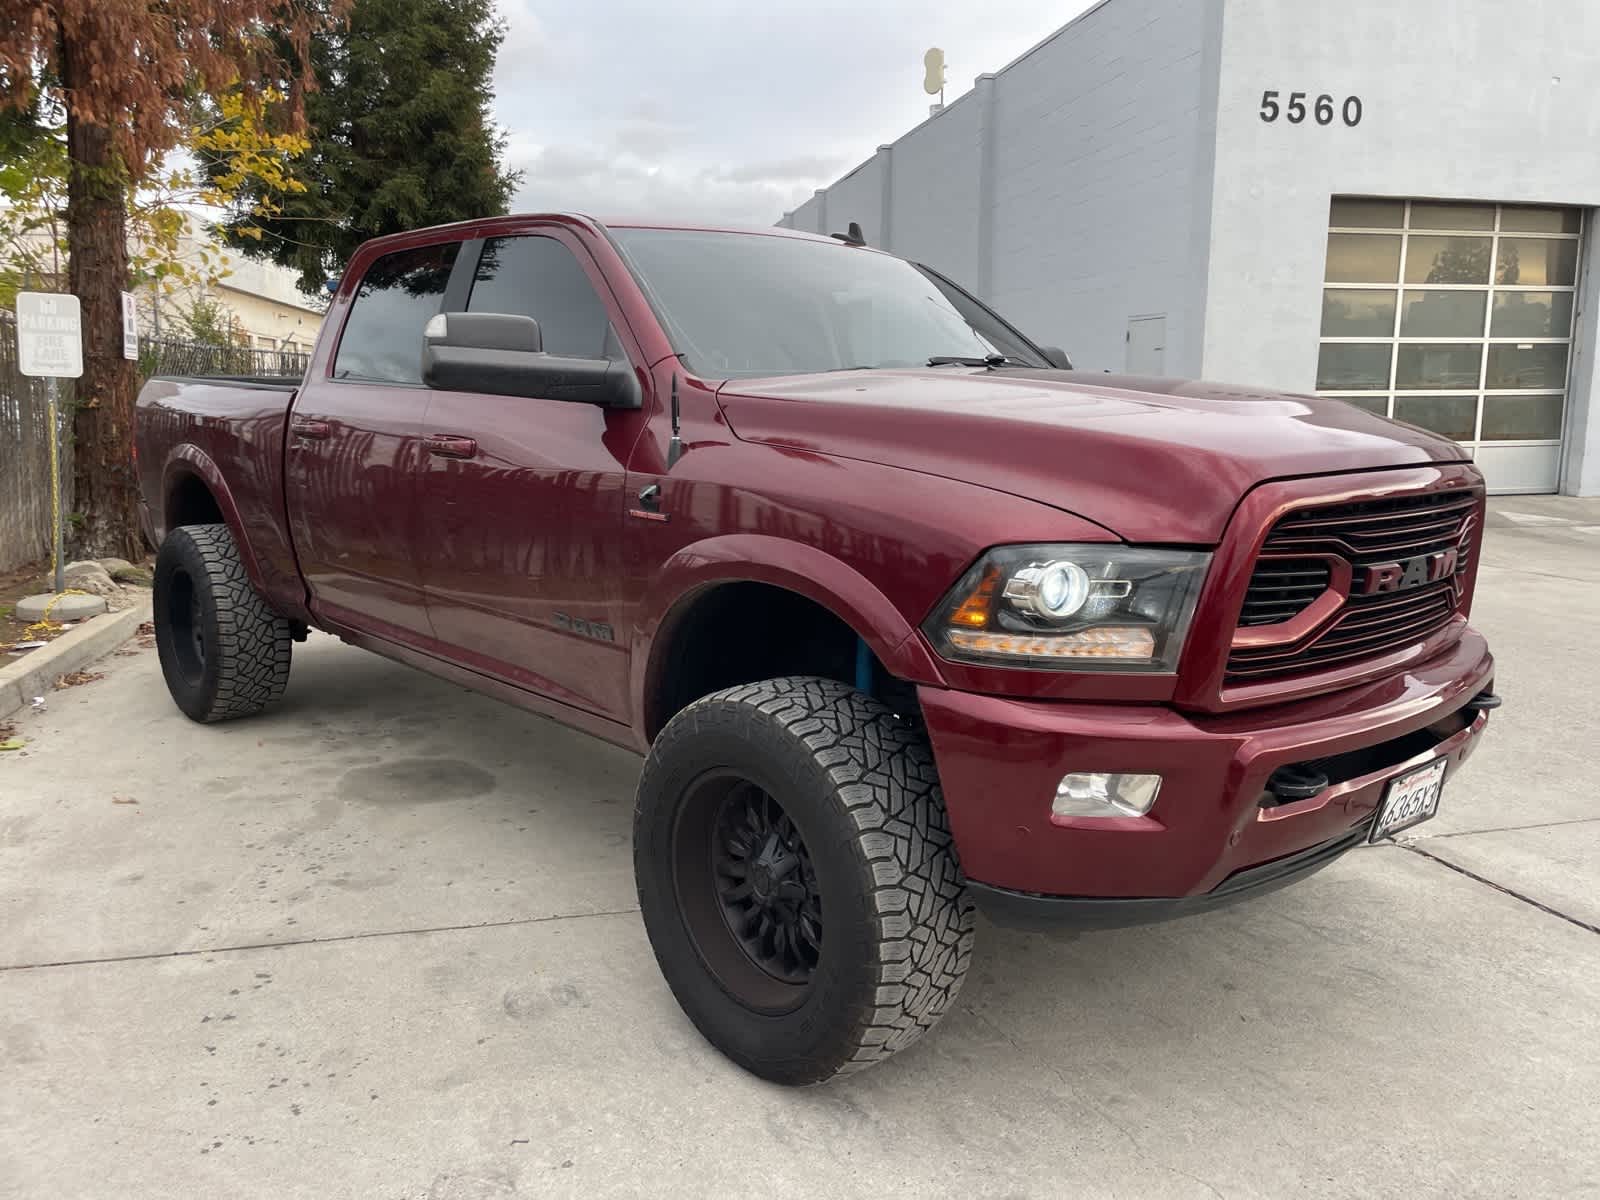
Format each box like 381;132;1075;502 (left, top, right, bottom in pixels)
1203;0;1600;493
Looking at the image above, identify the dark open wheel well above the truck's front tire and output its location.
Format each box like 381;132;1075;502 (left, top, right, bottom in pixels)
645;582;896;739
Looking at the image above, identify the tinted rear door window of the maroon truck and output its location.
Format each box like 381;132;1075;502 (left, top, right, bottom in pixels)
333;242;461;384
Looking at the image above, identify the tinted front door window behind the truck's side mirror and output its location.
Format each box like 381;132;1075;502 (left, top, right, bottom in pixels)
467;237;621;358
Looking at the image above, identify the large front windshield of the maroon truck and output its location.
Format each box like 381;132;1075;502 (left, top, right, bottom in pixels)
611;229;1048;379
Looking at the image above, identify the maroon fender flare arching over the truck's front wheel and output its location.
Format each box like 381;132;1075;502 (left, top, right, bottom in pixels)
629;533;944;741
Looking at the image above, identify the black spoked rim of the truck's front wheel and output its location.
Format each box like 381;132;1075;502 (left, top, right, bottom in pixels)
672;771;822;1014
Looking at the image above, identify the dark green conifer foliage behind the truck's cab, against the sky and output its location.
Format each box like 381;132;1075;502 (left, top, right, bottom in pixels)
212;0;518;293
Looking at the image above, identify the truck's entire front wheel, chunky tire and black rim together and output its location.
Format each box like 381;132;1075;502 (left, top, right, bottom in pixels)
634;678;973;1085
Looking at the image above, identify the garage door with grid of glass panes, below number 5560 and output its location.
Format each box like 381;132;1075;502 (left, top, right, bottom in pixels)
1317;198;1582;493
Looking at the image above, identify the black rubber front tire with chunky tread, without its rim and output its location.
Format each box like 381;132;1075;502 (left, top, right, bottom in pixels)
634;678;973;1085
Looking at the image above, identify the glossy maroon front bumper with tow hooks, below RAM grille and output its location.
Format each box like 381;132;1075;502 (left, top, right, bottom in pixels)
920;629;1494;926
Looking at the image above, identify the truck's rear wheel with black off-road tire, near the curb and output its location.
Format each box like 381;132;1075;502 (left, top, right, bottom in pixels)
154;525;291;723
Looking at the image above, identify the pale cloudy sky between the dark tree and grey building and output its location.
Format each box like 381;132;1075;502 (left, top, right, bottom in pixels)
494;0;1090;226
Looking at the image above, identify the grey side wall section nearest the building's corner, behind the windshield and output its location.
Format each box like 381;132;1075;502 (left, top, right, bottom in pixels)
989;0;1216;374
